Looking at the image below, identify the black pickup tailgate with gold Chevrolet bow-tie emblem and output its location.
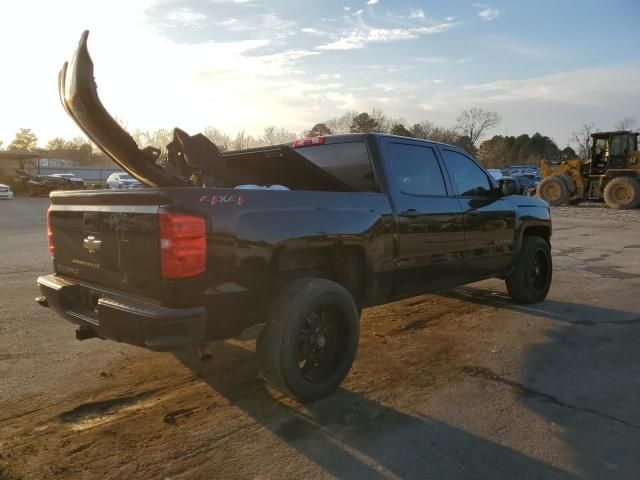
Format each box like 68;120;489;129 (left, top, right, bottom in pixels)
49;190;170;298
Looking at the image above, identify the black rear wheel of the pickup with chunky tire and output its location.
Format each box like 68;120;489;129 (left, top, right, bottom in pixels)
256;278;360;402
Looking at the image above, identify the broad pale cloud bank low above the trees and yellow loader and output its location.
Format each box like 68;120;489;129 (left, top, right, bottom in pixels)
406;65;640;144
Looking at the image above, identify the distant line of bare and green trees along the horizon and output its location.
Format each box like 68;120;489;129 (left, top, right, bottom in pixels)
0;107;636;168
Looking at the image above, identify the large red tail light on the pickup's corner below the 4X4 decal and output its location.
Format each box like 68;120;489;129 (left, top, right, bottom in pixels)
160;212;207;279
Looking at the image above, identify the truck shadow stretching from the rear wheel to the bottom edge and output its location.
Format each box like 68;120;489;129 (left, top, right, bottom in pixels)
176;343;576;480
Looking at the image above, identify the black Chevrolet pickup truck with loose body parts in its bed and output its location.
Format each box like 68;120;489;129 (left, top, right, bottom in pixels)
38;33;552;401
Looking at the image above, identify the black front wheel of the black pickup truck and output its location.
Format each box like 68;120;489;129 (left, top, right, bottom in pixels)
506;236;553;303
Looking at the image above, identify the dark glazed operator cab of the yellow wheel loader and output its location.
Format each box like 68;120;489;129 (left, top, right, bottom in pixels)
589;131;638;175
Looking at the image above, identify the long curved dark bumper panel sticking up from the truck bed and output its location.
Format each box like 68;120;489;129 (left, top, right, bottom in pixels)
58;30;189;187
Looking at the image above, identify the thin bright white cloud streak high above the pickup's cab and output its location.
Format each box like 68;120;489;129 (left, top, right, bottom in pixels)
315;22;457;50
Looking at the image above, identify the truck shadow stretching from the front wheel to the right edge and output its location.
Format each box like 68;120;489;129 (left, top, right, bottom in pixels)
440;287;640;479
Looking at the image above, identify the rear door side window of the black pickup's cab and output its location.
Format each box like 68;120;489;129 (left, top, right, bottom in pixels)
389;143;447;195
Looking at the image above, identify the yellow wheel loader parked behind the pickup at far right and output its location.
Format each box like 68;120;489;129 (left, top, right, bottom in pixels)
538;131;640;210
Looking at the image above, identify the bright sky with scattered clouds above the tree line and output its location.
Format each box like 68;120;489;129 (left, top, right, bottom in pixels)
0;0;640;147
